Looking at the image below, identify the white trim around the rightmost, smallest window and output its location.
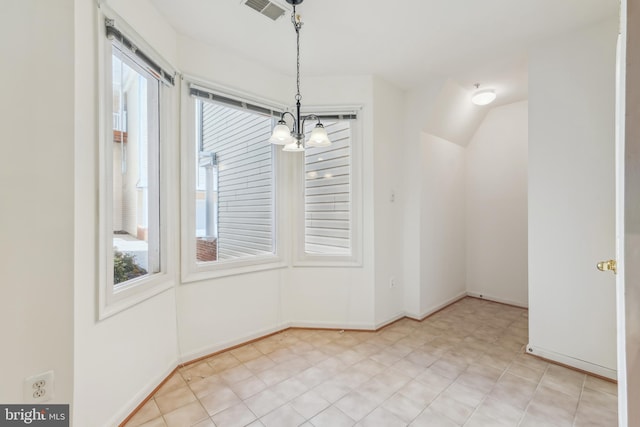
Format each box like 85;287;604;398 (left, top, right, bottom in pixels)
292;106;363;267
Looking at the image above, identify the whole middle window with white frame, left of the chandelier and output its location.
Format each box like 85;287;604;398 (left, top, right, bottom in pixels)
183;85;280;281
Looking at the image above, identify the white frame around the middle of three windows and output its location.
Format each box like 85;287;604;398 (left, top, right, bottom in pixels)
180;77;287;284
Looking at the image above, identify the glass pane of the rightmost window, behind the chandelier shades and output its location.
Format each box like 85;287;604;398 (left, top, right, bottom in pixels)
304;120;352;255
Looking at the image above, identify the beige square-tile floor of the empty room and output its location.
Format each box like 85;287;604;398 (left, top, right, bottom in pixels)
122;298;617;427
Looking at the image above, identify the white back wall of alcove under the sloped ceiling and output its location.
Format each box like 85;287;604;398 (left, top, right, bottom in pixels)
466;101;528;307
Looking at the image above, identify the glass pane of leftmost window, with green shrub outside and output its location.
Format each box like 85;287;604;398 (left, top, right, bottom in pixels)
112;45;160;285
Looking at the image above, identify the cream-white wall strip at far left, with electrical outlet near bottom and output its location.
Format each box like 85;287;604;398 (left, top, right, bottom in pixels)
0;0;74;403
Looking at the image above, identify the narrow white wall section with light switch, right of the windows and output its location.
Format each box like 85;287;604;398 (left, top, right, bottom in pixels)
373;78;407;325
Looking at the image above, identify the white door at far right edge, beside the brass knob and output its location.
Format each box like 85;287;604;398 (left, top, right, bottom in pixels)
616;0;640;427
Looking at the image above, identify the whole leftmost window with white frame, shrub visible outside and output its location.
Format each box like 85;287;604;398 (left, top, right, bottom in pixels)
99;19;173;318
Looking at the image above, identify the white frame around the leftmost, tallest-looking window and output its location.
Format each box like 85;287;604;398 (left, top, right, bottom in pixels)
97;11;175;320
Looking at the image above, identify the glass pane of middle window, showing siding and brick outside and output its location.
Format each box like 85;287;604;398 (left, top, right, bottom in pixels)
195;99;275;262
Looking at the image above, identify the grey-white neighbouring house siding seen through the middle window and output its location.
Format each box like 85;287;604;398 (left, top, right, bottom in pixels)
202;102;274;260
